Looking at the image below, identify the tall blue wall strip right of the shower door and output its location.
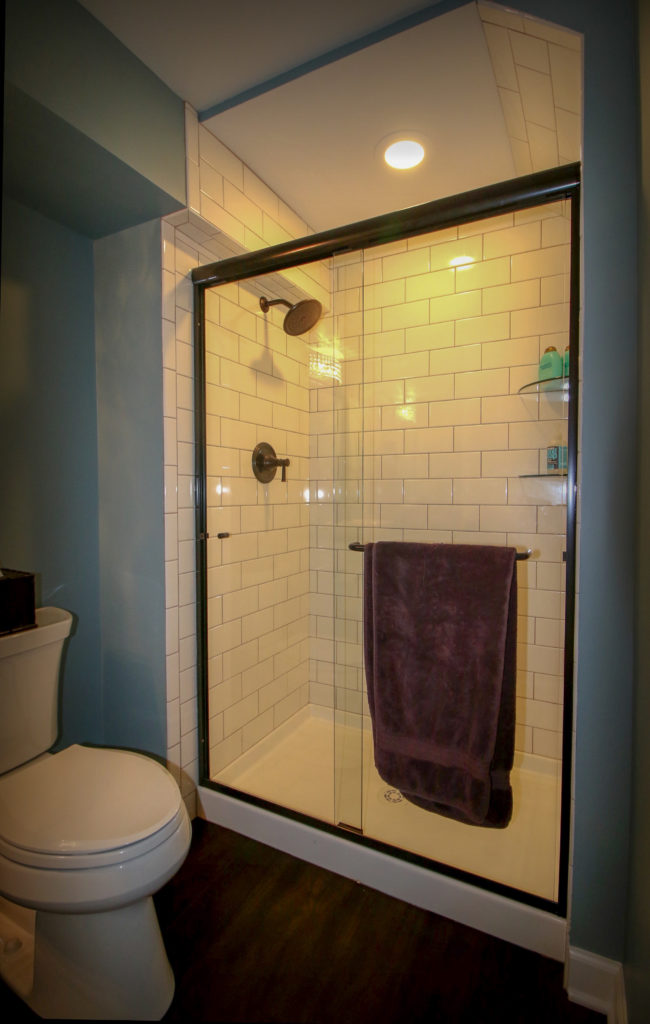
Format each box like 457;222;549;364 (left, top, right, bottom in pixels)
518;0;638;961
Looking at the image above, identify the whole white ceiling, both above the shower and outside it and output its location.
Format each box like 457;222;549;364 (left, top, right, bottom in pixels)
80;0;581;230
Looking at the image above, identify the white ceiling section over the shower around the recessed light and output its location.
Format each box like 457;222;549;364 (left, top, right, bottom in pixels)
206;4;515;229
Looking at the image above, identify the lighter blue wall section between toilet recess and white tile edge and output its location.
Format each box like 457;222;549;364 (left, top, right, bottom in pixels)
94;221;167;757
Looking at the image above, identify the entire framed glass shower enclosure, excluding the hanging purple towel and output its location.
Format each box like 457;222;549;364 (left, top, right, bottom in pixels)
192;165;579;913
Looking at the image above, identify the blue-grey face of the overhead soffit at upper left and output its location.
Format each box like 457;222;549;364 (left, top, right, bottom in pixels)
5;0;185;212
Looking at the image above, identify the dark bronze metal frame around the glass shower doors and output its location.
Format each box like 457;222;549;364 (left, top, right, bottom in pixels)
191;163;580;916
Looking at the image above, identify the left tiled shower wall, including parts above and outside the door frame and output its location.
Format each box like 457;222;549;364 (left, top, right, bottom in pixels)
162;105;325;790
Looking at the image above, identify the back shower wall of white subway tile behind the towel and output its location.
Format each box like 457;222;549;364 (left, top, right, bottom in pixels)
310;203;569;759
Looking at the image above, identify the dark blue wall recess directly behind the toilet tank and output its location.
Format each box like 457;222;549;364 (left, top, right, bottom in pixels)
0;200;103;742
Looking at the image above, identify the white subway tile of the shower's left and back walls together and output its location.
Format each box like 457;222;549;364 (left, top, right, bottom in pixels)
162;108;569;809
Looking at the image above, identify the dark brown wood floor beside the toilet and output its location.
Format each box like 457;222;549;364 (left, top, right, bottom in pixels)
156;820;605;1024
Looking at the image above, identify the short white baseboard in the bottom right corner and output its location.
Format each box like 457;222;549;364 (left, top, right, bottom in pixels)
566;946;627;1024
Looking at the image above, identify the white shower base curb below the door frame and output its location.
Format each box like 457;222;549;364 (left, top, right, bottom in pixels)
198;786;566;962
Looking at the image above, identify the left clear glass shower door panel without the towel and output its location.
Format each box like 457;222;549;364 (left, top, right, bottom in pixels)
206;264;334;821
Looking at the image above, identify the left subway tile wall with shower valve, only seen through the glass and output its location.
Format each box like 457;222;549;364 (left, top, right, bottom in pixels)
206;280;317;776
